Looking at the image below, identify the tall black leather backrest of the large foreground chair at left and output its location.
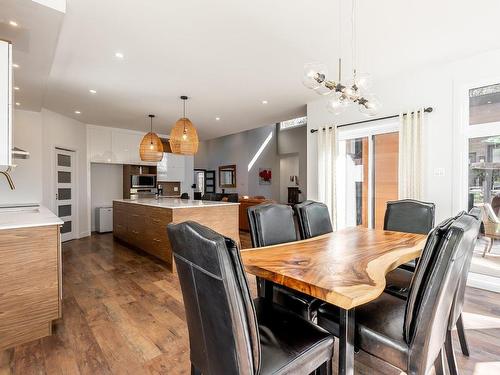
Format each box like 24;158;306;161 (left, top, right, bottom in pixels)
167;221;260;375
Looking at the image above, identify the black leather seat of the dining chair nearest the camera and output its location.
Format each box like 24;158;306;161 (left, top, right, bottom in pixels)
254;298;333;375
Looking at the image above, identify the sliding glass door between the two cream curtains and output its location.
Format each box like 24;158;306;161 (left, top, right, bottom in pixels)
337;121;399;228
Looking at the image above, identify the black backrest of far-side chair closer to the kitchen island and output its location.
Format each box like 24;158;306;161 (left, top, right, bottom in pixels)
247;203;297;247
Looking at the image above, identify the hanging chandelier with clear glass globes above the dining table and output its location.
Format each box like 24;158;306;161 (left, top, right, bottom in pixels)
302;0;380;116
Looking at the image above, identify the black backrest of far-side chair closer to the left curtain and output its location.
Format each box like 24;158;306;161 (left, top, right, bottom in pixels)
293;200;333;239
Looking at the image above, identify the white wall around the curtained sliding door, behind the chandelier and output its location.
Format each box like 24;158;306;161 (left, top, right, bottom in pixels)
307;51;500;225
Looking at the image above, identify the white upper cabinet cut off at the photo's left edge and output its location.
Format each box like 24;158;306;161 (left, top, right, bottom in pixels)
0;40;12;169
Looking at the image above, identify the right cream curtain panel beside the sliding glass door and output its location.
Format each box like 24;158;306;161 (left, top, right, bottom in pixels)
398;108;425;199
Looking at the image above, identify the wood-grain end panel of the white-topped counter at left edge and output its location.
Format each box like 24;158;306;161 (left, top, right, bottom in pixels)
0;225;62;351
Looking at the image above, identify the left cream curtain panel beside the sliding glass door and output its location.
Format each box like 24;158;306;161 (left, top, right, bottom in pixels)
317;126;338;230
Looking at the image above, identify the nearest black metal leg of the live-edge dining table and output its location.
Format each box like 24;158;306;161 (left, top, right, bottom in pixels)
339;309;354;375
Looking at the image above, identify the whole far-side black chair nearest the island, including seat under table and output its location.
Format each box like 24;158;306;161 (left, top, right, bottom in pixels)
247;203;321;321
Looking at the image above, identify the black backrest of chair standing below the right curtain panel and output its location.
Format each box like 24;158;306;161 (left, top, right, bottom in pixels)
384;199;435;234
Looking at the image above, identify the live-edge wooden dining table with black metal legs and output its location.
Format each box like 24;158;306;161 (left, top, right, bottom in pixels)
241;227;427;375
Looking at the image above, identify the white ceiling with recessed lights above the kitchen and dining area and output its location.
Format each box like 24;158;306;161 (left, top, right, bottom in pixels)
0;0;500;139
